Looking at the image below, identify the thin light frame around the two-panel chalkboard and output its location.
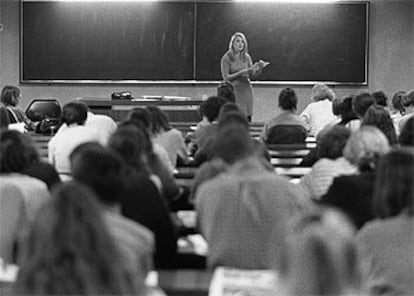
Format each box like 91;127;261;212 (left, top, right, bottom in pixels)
19;0;369;86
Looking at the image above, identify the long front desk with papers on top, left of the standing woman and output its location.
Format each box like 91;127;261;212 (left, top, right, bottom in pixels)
81;97;203;122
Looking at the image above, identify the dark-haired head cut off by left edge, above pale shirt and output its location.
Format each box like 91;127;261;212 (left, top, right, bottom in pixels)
0;129;40;173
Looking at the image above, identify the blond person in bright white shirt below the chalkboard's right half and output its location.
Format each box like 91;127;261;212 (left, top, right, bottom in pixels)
300;83;336;136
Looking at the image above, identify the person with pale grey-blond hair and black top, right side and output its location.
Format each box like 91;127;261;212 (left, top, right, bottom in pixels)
320;126;390;229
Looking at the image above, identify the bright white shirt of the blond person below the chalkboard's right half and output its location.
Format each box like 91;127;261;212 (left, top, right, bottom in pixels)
300;99;337;136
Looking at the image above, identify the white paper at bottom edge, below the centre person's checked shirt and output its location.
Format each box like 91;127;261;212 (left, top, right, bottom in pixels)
209;267;278;296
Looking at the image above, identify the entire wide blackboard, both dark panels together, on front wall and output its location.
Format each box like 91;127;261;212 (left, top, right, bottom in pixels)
20;0;368;84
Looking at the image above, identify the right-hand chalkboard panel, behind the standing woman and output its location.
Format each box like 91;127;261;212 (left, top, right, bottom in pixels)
196;2;367;84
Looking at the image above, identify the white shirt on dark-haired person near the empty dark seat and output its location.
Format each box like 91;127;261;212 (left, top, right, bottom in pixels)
48;124;101;174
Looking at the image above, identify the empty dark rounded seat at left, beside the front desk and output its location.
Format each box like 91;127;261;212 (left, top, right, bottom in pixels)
26;99;62;121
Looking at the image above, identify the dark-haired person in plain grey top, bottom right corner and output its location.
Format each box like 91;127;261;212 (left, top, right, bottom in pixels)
356;148;414;295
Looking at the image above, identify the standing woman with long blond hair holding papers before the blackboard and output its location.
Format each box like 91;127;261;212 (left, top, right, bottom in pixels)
221;32;264;121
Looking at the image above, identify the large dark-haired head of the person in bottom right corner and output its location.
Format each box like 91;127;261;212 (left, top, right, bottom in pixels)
373;147;414;218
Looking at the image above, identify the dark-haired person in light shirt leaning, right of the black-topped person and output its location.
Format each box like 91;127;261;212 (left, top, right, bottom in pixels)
146;106;189;167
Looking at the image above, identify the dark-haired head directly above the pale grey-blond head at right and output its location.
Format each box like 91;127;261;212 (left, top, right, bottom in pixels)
361;105;397;145
